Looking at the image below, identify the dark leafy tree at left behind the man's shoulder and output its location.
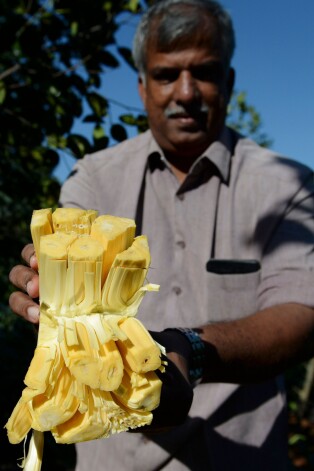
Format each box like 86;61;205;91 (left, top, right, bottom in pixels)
0;0;144;318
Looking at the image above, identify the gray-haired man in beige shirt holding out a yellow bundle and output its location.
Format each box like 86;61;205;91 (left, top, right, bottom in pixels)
10;0;314;471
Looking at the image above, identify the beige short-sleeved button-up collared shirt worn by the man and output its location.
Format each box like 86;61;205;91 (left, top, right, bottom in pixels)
60;128;314;471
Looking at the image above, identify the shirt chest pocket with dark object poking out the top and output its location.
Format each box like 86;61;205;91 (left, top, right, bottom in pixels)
206;259;261;322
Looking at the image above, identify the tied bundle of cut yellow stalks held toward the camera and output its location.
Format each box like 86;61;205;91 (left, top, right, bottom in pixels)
5;208;163;471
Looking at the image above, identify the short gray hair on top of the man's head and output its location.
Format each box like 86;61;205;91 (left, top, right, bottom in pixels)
133;0;235;77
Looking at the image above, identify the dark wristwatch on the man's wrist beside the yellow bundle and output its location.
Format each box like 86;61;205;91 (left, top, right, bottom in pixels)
177;327;205;387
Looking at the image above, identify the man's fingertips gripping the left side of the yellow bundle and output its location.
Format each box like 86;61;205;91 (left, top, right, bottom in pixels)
9;244;39;324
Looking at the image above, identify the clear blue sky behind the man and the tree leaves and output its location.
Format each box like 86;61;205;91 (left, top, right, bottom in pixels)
56;0;314;182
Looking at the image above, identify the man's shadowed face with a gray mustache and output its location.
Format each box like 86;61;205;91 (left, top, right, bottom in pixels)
139;45;233;158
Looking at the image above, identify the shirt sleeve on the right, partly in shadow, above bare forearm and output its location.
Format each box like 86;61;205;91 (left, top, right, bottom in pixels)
259;172;314;309
